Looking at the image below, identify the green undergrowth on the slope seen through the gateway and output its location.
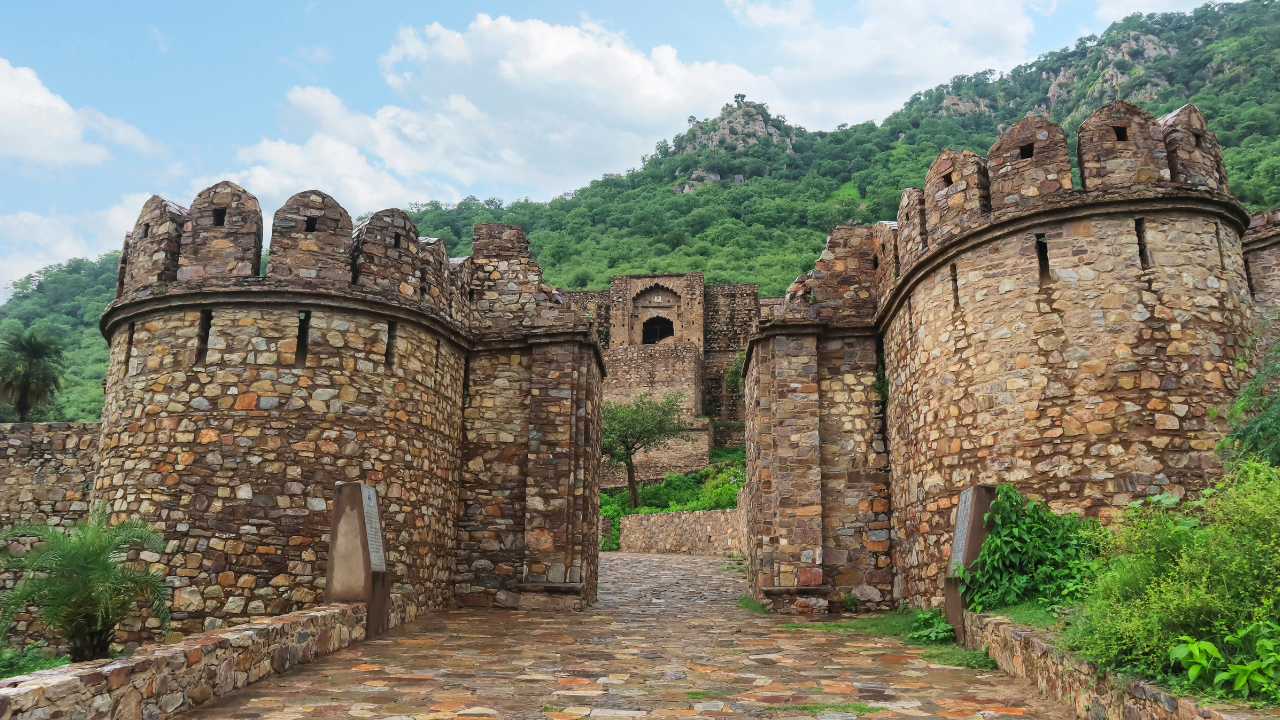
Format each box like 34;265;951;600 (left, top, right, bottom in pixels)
600;458;746;550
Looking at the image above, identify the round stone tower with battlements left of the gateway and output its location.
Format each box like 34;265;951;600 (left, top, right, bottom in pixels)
95;182;603;632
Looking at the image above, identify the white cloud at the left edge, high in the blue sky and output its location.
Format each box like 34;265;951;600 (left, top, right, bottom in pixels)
0;58;161;165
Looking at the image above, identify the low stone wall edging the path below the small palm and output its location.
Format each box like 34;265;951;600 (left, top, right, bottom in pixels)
0;594;417;720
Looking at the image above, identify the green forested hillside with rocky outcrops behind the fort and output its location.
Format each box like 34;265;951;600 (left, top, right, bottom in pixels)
0;0;1280;420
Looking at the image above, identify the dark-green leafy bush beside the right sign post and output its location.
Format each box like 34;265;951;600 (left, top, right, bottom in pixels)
957;484;1102;611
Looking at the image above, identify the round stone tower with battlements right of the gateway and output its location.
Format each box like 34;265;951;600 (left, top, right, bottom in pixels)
742;101;1276;611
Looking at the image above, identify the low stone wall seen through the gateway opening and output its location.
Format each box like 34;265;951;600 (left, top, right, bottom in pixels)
618;509;742;555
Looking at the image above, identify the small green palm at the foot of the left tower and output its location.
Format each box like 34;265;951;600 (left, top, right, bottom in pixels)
0;502;170;662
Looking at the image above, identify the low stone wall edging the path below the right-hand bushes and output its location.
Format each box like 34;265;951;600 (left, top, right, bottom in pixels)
964;612;1263;720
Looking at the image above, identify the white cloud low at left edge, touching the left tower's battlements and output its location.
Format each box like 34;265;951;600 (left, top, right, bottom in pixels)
0;193;150;296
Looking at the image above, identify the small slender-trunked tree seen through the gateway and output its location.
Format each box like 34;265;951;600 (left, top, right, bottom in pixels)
600;392;692;507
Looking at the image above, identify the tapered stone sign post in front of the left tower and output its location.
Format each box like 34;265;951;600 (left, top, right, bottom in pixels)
325;483;392;637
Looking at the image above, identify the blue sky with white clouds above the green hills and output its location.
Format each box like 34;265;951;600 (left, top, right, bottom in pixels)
0;0;1228;286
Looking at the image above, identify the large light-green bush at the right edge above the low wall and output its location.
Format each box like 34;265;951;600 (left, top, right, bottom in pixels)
1066;460;1280;682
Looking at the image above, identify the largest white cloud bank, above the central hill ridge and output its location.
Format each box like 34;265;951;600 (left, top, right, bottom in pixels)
217;0;1052;207
